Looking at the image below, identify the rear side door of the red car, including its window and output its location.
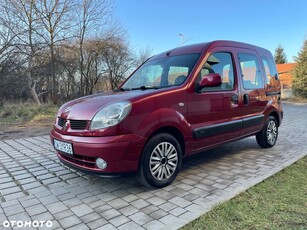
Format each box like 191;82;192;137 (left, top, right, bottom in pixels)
237;49;266;136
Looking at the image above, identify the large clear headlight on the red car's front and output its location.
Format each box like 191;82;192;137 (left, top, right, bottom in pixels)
90;101;131;130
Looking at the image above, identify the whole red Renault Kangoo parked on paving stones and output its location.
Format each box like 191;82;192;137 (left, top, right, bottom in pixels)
50;41;283;187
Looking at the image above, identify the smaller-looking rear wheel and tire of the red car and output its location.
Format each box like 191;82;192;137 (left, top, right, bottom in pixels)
256;116;278;148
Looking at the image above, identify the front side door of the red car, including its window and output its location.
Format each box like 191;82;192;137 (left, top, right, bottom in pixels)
188;47;242;151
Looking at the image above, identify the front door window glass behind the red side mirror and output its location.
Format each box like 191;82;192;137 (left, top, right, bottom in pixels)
198;52;234;91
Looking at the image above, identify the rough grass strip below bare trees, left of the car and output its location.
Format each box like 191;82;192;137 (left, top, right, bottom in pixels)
0;102;58;126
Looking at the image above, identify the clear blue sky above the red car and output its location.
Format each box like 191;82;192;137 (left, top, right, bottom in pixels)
114;0;307;62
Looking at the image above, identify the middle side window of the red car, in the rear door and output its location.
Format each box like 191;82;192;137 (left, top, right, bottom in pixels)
238;53;264;89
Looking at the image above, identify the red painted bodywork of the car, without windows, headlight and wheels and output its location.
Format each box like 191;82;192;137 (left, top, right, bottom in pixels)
50;41;283;174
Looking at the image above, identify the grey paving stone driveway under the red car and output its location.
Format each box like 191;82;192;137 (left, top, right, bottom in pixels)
0;104;307;230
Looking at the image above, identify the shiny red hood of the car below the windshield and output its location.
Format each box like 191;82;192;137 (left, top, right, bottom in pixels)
58;90;154;120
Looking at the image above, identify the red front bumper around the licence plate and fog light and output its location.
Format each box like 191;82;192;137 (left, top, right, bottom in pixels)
50;130;146;176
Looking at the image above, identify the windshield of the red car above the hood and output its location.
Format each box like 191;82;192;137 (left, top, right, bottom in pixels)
122;54;200;90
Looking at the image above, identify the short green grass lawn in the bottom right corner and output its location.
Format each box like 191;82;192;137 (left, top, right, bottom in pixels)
182;157;307;230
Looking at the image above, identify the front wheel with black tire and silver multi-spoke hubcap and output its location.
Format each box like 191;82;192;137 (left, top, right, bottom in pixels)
137;133;182;188
